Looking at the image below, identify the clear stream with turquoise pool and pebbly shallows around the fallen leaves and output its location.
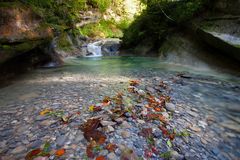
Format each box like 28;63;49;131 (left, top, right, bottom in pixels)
0;56;240;160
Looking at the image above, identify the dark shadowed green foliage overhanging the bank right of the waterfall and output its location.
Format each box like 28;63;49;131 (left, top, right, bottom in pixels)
123;0;209;47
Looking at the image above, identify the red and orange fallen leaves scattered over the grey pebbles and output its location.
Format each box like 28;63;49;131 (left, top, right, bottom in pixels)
25;80;189;160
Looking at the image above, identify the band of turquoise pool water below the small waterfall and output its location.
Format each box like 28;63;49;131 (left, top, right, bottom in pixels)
57;57;240;82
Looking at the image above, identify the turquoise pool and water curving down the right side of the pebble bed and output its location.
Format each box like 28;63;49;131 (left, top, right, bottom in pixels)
0;57;240;158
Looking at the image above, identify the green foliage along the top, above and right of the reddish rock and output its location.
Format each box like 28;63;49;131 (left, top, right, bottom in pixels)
24;0;111;29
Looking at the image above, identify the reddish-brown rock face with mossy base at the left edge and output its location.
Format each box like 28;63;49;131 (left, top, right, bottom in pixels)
0;2;53;64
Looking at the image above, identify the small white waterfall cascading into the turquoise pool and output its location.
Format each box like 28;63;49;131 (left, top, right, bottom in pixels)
86;41;102;57
